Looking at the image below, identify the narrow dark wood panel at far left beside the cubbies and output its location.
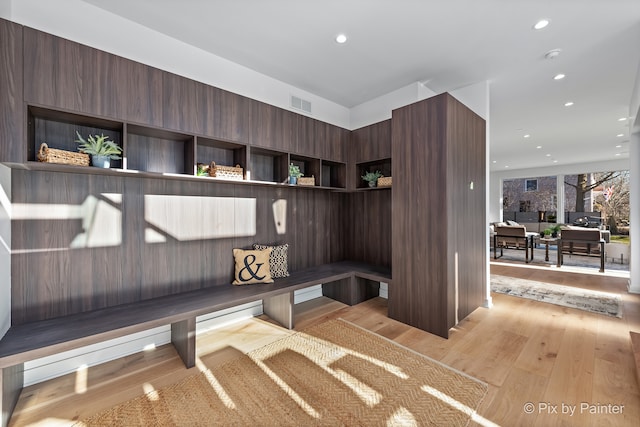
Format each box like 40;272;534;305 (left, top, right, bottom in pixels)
0;19;27;162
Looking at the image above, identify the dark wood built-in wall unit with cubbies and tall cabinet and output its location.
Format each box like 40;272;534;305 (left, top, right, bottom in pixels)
0;20;485;335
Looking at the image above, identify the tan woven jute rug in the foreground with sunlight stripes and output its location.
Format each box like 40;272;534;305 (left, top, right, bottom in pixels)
78;320;487;426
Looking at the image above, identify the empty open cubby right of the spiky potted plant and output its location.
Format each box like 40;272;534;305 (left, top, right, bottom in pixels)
125;124;195;175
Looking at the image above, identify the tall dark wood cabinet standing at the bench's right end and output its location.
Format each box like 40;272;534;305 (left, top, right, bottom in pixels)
389;93;487;337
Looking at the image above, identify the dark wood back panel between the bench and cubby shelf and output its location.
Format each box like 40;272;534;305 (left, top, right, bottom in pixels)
11;169;344;324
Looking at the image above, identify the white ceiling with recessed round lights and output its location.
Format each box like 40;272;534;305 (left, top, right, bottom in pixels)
86;0;640;171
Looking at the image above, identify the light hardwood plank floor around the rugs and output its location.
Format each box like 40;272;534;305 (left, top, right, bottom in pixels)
11;263;640;426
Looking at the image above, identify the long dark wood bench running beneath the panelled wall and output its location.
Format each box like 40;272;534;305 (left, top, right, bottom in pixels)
0;261;391;426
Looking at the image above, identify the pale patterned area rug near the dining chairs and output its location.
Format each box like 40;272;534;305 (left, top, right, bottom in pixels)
491;274;622;317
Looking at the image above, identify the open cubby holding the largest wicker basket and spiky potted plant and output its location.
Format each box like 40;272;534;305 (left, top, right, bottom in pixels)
27;106;123;169
